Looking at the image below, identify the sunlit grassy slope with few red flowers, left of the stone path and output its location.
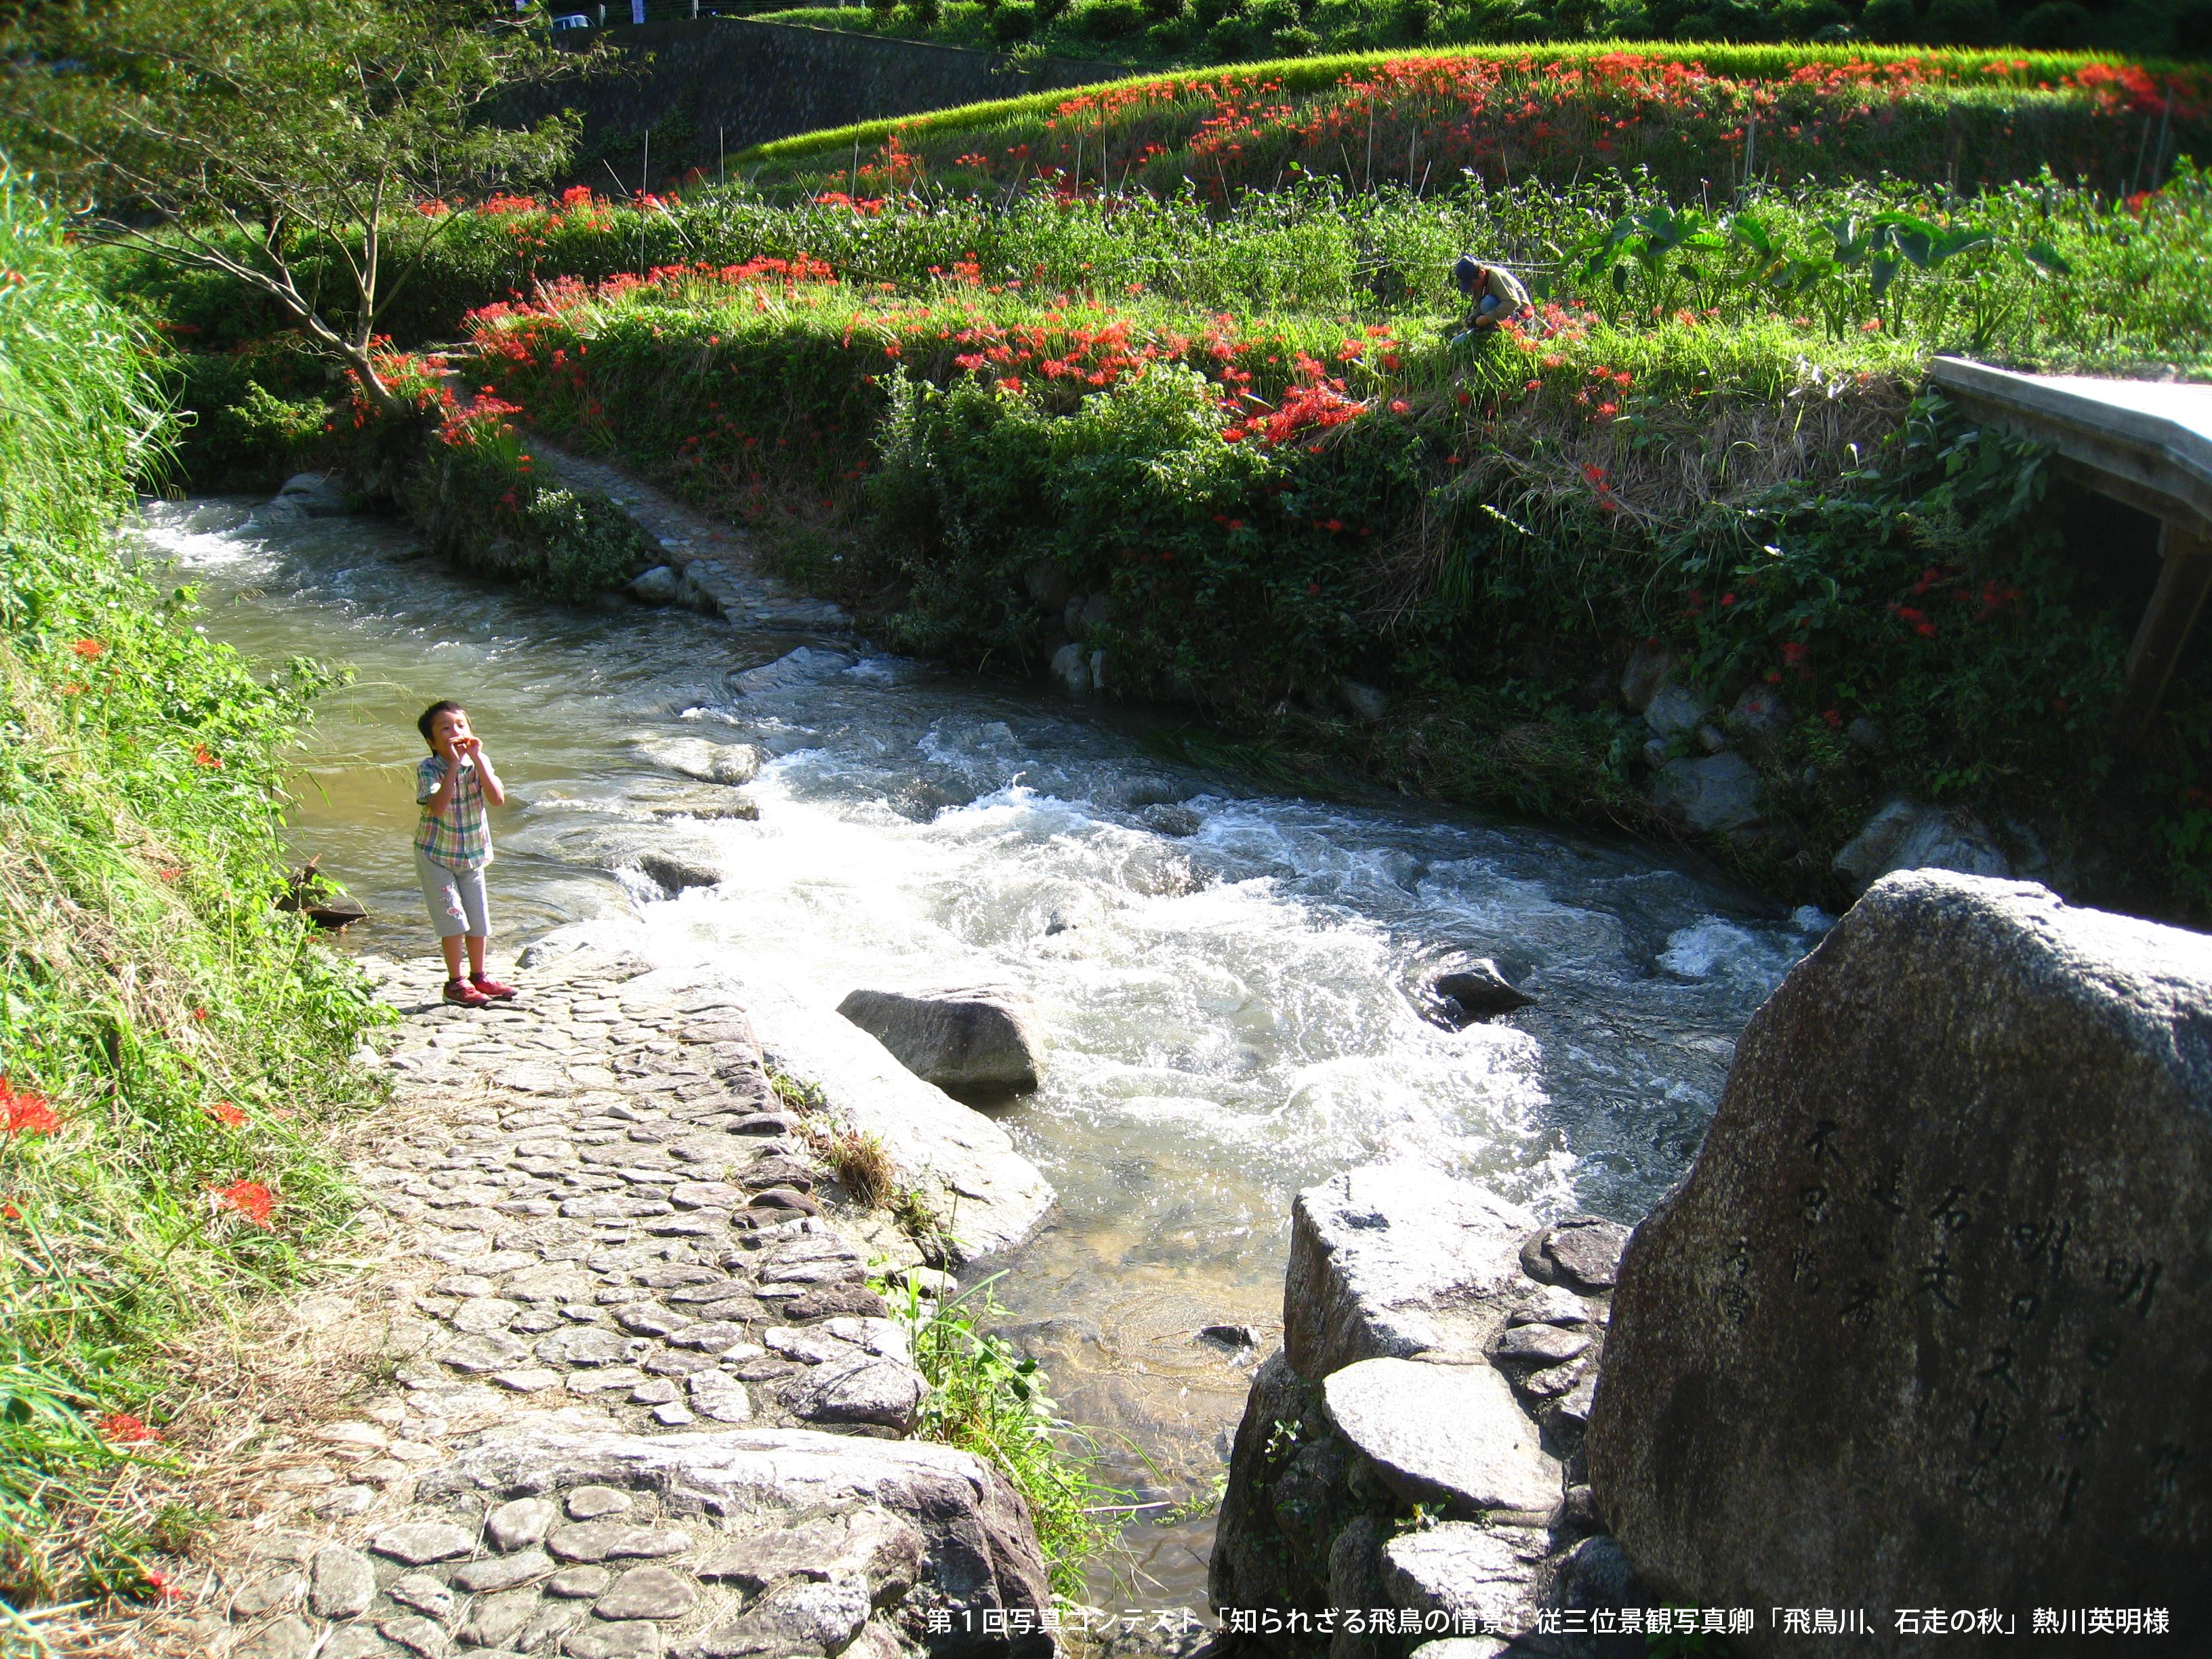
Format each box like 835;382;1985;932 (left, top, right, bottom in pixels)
0;184;369;1628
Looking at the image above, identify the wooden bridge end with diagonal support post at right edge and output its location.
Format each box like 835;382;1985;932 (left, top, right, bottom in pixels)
1929;356;2212;750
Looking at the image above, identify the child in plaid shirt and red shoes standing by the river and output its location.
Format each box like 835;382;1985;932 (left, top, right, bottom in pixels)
416;701;516;1008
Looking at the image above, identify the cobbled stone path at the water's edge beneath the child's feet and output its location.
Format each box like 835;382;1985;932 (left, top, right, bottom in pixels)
192;951;1046;1659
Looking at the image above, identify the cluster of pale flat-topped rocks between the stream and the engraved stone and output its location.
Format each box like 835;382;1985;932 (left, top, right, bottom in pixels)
1210;1164;1603;1659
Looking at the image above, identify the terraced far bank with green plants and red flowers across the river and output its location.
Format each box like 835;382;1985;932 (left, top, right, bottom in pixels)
121;49;2212;914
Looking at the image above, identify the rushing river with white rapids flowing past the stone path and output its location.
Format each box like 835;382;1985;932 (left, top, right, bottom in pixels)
144;500;1825;1606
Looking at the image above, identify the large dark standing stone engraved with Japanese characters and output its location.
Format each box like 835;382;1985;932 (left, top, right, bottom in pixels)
1586;872;2212;1657
